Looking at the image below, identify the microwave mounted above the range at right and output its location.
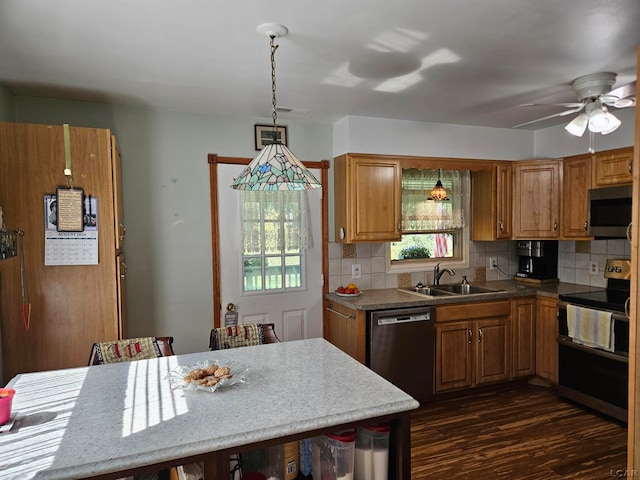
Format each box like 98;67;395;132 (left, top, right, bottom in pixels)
589;185;632;238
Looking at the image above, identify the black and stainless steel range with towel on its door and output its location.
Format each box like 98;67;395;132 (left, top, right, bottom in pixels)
558;260;631;422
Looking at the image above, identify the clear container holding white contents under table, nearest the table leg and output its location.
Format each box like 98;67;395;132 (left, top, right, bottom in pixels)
354;423;391;480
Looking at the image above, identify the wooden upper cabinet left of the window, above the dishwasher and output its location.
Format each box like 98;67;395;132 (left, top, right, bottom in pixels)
334;154;402;243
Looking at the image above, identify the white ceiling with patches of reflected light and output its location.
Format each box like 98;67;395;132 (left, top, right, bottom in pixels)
0;0;640;129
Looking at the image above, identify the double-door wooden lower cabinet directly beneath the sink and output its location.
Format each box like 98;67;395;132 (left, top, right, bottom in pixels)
435;301;511;393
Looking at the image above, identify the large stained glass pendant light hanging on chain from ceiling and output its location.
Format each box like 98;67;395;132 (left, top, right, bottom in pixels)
231;23;321;190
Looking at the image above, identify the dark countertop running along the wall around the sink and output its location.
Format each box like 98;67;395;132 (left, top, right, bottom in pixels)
324;280;602;310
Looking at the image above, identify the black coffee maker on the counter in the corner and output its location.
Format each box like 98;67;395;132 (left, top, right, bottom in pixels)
516;240;558;280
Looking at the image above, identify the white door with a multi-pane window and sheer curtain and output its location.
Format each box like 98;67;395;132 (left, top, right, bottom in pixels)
218;164;322;340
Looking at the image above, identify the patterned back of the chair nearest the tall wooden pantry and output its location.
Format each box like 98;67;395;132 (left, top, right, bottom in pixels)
88;337;174;366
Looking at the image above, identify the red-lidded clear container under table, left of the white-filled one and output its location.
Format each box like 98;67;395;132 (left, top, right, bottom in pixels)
311;430;356;480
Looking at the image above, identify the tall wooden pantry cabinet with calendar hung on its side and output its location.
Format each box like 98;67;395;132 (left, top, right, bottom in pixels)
0;123;126;384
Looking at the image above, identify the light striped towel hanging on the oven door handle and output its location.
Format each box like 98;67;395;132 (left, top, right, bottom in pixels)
567;305;615;352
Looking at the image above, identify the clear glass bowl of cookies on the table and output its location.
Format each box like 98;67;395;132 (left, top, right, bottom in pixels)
167;360;247;392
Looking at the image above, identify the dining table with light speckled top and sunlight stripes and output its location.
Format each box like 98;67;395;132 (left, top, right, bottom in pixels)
0;338;420;480
